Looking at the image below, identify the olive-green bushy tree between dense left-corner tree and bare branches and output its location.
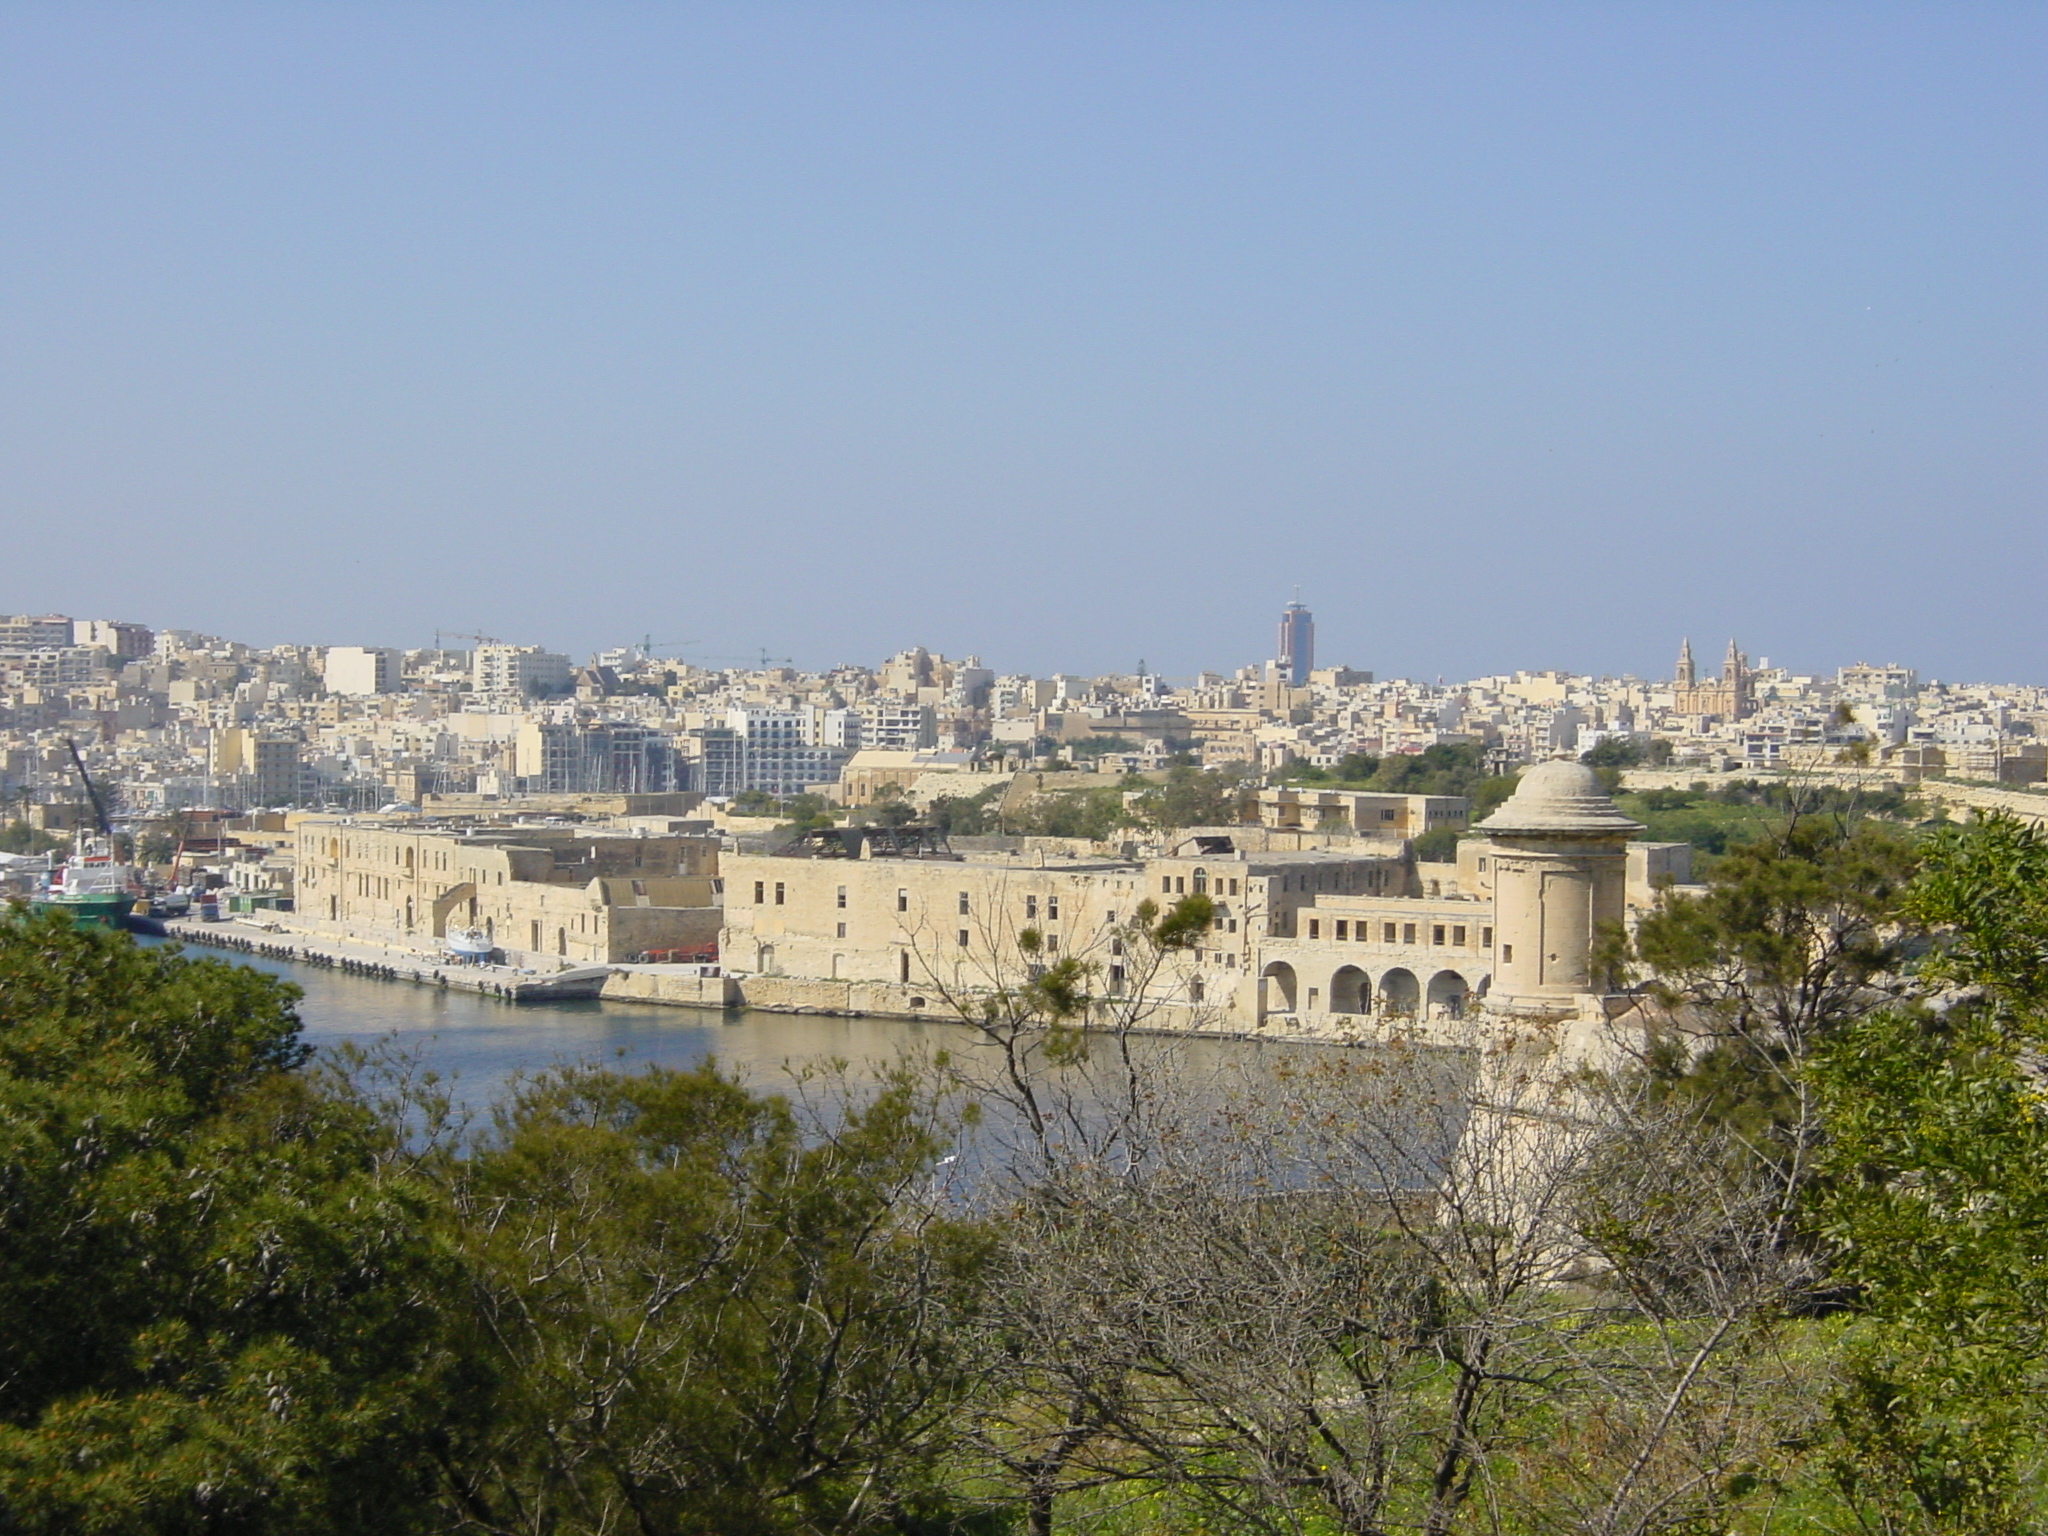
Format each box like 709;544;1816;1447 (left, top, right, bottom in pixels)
453;1065;987;1534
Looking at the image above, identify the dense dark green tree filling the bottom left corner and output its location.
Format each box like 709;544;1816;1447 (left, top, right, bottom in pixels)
0;913;471;1536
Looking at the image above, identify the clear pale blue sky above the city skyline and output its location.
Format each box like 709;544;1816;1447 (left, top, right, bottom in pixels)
0;0;2048;682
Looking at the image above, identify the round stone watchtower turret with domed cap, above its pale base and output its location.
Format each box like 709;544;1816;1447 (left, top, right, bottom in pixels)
1477;762;1642;1016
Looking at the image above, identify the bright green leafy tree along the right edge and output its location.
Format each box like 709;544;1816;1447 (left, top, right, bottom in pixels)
1810;815;2048;1534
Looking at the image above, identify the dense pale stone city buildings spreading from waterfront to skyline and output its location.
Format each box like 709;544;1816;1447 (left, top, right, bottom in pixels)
0;602;2048;1026
